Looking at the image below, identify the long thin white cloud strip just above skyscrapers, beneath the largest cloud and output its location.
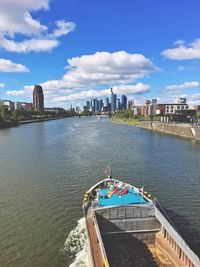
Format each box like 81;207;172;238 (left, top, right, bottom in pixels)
53;83;150;102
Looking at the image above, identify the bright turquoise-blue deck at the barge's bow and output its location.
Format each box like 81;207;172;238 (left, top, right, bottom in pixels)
98;188;147;207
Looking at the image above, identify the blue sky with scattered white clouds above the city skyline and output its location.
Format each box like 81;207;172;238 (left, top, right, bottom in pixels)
0;0;200;108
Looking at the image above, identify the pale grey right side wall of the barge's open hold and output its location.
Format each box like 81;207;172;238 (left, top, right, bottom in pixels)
155;207;200;266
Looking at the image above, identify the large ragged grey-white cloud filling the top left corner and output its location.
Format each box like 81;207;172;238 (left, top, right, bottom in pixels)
0;0;75;53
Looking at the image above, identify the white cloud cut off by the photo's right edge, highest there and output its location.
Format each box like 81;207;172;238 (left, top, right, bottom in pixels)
161;39;200;60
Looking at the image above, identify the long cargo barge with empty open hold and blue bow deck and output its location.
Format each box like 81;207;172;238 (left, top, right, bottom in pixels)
83;169;200;267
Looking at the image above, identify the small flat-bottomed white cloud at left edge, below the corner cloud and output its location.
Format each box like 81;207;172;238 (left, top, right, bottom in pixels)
0;58;30;72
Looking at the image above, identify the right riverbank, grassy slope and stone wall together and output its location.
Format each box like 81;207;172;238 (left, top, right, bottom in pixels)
112;118;200;141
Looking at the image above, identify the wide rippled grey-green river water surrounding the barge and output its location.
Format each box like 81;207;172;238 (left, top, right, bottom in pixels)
0;117;200;267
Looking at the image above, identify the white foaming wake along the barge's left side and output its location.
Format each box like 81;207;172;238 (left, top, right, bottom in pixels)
62;218;88;267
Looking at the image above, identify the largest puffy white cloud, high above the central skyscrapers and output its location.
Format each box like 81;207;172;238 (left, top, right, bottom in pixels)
55;51;158;89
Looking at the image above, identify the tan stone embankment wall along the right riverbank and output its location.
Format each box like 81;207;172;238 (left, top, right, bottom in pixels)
138;121;200;141
